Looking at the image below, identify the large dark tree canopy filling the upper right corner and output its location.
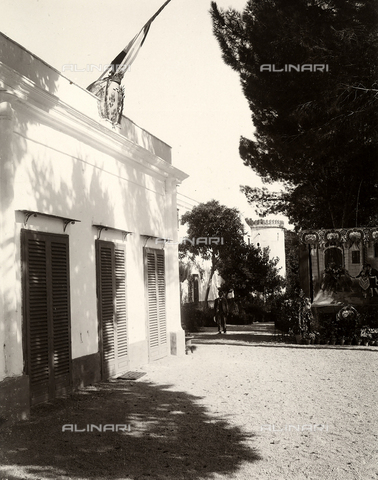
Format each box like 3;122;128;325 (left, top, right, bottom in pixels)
211;0;378;228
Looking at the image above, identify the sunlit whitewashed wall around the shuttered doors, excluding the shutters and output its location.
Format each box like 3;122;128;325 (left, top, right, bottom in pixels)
0;31;187;398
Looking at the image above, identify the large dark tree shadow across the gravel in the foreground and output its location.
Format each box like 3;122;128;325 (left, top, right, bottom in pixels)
0;380;260;480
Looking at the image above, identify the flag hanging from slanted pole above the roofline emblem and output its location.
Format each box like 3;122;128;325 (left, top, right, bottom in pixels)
87;0;171;96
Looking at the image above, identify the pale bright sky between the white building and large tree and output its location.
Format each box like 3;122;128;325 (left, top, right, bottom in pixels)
0;0;280;225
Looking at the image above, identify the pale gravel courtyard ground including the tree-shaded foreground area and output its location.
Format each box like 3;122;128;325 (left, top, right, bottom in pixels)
0;324;378;480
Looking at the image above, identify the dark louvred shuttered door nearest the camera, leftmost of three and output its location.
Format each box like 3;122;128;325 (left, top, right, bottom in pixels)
22;230;71;405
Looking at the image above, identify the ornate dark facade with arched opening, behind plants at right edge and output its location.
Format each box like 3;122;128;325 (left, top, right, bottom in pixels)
300;227;378;308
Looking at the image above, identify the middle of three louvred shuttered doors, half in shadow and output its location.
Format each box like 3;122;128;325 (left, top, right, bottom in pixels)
96;240;129;379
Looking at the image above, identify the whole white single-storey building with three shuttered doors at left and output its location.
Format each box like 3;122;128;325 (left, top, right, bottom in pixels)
0;34;187;418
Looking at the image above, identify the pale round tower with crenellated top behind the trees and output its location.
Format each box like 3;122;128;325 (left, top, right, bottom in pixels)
246;218;286;278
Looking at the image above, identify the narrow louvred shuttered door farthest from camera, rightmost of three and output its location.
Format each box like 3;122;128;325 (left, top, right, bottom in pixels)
145;248;168;360
